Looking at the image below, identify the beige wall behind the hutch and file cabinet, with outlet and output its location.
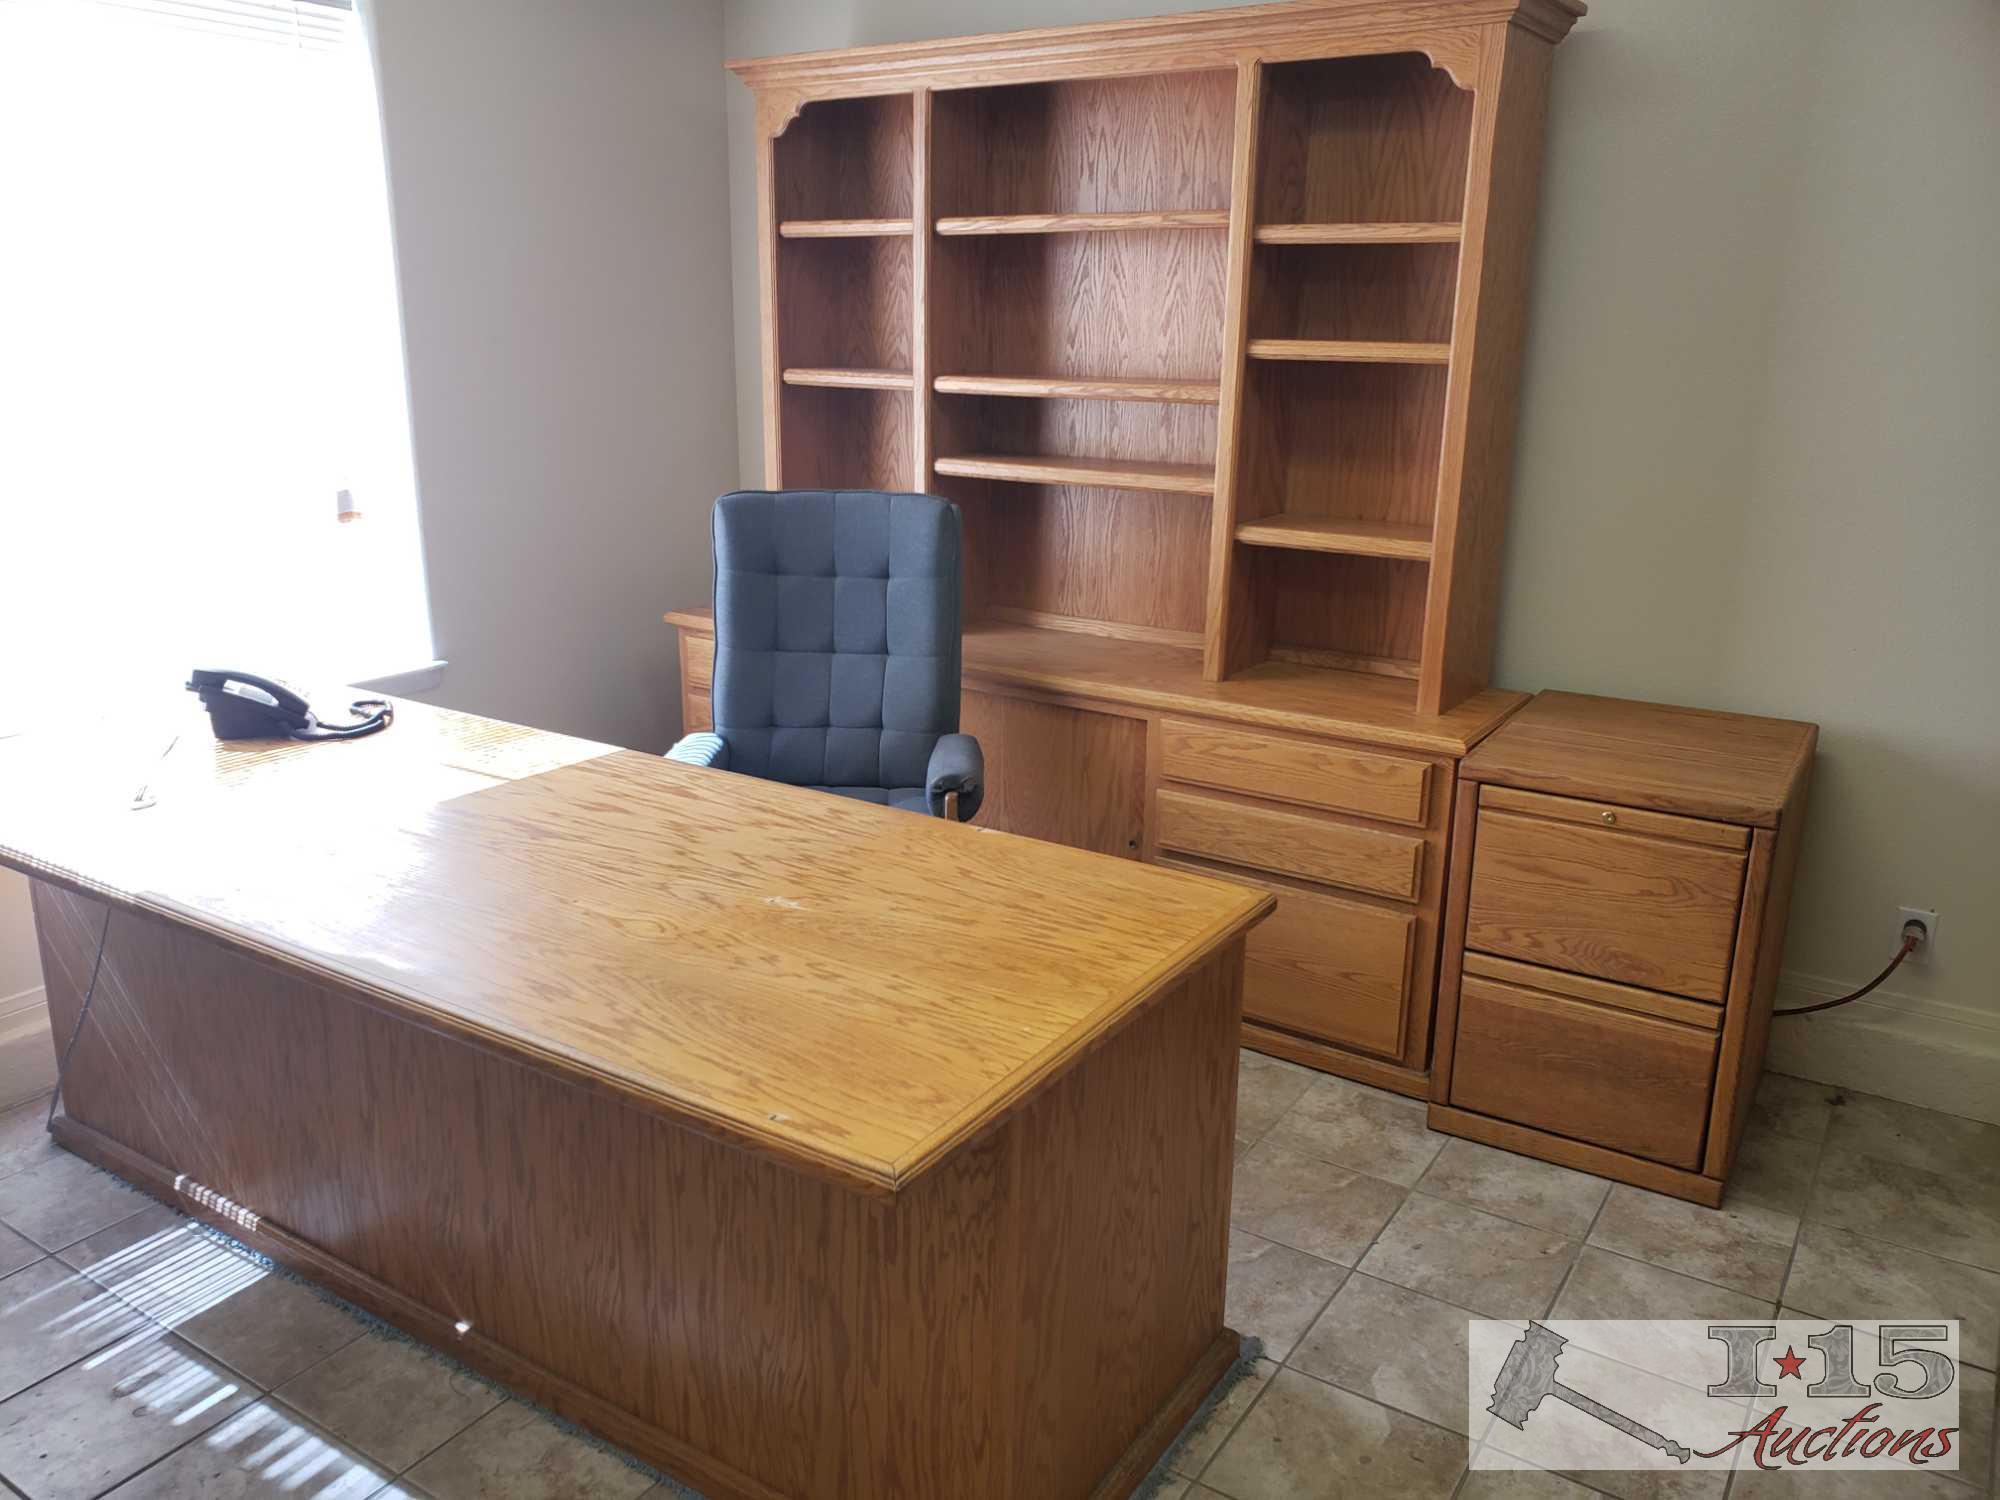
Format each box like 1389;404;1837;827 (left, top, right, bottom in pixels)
726;0;2000;1110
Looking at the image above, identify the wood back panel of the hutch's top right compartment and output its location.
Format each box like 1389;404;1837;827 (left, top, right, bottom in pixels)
1258;52;1472;224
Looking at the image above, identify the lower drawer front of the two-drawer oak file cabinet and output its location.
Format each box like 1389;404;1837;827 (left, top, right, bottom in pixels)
1452;974;1718;1172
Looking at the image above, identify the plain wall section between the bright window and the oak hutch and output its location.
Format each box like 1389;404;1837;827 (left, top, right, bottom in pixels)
372;0;736;750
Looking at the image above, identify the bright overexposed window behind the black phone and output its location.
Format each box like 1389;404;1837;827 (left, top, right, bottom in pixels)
0;0;432;718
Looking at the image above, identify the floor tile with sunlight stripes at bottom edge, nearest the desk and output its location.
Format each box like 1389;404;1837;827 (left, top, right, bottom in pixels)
106;1400;394;1500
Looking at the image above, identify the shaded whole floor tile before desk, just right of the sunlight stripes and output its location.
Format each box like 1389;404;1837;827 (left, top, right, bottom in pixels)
278;1334;500;1472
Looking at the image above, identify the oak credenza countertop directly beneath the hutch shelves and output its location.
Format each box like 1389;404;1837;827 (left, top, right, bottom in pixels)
664;606;1528;756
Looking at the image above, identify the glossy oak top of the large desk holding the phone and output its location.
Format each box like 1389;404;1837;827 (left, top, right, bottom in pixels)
0;700;1272;1192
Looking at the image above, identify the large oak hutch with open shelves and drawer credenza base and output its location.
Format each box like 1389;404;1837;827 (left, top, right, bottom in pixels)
666;0;1584;1094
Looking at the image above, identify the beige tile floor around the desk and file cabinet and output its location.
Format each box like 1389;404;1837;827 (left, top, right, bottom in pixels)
0;1052;2000;1500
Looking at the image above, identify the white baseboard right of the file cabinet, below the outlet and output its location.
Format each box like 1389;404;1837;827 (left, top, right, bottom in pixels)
1764;974;2000;1124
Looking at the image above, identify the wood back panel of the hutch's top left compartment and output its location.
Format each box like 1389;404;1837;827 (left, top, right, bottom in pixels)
776;94;912;220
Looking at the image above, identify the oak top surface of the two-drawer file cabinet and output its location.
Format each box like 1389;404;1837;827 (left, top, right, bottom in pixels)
1464;692;1818;828
